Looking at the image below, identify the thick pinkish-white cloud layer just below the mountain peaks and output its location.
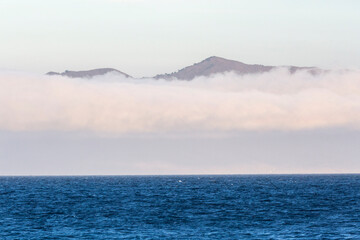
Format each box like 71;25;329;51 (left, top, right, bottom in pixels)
0;69;360;134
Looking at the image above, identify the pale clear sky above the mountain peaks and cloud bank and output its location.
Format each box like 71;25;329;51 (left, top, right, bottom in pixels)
0;0;360;77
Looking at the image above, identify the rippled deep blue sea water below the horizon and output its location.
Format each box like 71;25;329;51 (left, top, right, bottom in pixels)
0;175;360;239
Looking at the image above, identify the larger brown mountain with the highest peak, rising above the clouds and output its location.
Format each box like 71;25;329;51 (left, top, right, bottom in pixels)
154;56;319;80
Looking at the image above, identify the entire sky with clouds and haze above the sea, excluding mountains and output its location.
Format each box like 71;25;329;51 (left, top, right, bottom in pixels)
0;0;360;175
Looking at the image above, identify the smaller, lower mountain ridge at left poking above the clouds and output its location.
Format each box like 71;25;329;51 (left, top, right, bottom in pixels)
46;68;131;78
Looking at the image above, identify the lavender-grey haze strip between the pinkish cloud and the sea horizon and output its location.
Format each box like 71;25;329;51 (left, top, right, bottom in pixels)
0;129;360;175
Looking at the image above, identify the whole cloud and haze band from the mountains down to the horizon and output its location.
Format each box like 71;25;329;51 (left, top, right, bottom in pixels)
0;65;360;175
